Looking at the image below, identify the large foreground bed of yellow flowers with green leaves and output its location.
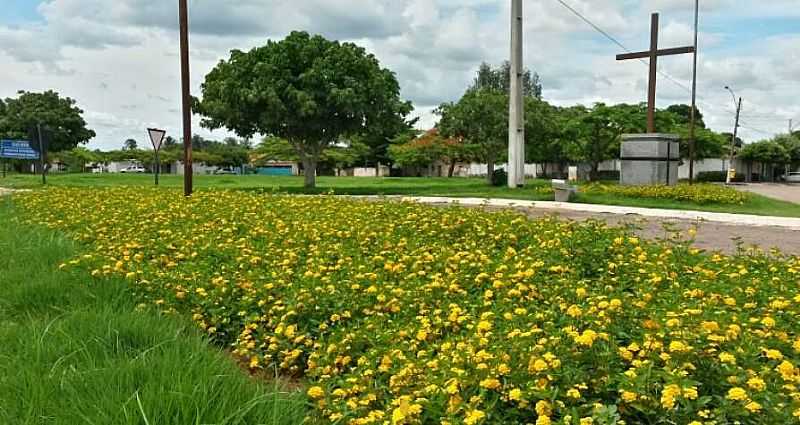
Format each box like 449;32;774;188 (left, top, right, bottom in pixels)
17;188;800;425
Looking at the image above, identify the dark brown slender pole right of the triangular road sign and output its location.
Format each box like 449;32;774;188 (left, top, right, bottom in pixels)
178;0;193;196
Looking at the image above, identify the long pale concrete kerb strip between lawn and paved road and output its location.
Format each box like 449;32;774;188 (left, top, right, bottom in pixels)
366;196;800;231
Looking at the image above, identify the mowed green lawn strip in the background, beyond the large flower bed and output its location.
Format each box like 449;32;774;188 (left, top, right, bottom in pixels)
0;174;800;217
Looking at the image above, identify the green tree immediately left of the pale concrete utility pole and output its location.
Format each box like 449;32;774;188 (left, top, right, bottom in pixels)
436;89;508;184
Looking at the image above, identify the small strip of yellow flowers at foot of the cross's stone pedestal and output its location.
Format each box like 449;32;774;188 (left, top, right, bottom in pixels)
581;183;750;205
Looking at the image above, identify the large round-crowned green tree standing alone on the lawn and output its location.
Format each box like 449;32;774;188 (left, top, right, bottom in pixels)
195;32;400;187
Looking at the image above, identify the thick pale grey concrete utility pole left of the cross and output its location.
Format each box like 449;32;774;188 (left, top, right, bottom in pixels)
508;0;525;188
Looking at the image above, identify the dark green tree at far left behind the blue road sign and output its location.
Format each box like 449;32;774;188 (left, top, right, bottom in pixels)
0;90;95;152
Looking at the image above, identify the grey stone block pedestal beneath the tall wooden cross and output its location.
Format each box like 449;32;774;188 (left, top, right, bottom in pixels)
620;133;681;186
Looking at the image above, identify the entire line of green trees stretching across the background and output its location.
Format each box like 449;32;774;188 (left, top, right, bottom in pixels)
0;31;798;187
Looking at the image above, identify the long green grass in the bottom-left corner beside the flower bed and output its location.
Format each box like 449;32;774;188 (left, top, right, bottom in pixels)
0;198;306;425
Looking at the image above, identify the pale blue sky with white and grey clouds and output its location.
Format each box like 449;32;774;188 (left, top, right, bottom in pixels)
0;0;800;149
